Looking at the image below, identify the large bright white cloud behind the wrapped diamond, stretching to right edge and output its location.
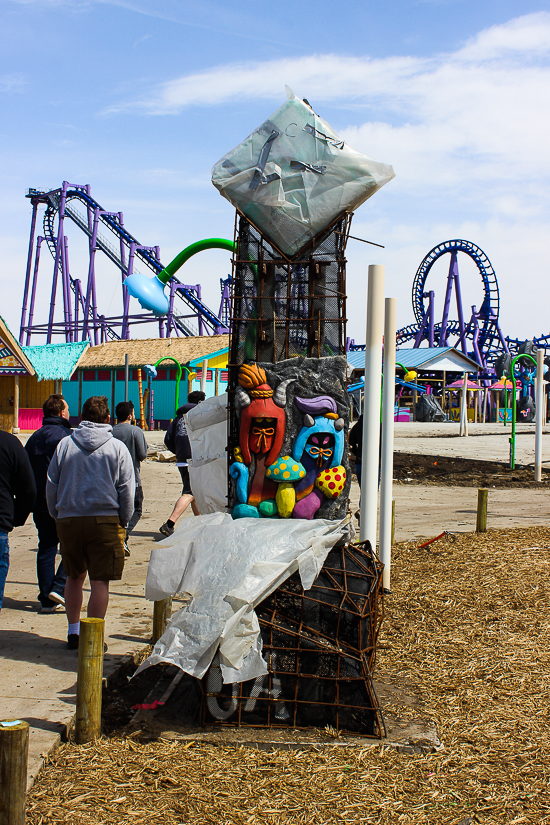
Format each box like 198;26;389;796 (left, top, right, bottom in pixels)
106;12;550;200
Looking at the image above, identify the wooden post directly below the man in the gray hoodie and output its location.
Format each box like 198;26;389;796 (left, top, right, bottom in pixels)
75;619;105;745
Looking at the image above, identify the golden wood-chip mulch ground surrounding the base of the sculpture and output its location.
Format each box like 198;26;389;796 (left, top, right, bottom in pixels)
26;528;550;825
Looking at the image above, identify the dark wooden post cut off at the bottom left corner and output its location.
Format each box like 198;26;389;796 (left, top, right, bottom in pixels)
0;719;29;825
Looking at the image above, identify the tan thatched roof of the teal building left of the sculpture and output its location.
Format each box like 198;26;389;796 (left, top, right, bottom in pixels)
78;335;229;369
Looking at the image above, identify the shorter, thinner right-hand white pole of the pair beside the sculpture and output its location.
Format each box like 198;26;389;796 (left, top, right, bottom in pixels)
380;298;397;592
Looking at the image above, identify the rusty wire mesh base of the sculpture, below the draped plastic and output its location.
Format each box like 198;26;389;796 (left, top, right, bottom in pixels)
202;542;385;738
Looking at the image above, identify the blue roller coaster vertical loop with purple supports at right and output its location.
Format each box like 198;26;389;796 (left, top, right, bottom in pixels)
350;240;550;386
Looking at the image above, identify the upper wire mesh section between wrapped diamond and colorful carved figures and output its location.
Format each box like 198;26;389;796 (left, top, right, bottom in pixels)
230;214;351;365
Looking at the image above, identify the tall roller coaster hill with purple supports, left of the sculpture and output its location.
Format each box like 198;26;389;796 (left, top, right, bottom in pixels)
19;181;231;345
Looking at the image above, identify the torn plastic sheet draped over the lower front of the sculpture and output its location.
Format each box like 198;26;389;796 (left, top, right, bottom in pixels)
137;513;354;683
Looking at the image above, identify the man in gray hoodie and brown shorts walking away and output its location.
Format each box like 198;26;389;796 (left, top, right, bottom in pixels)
46;395;135;650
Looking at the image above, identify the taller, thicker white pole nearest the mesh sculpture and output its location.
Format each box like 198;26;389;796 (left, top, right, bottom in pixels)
359;264;384;550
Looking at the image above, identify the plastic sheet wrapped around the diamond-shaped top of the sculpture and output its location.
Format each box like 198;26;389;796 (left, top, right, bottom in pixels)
212;88;395;257
